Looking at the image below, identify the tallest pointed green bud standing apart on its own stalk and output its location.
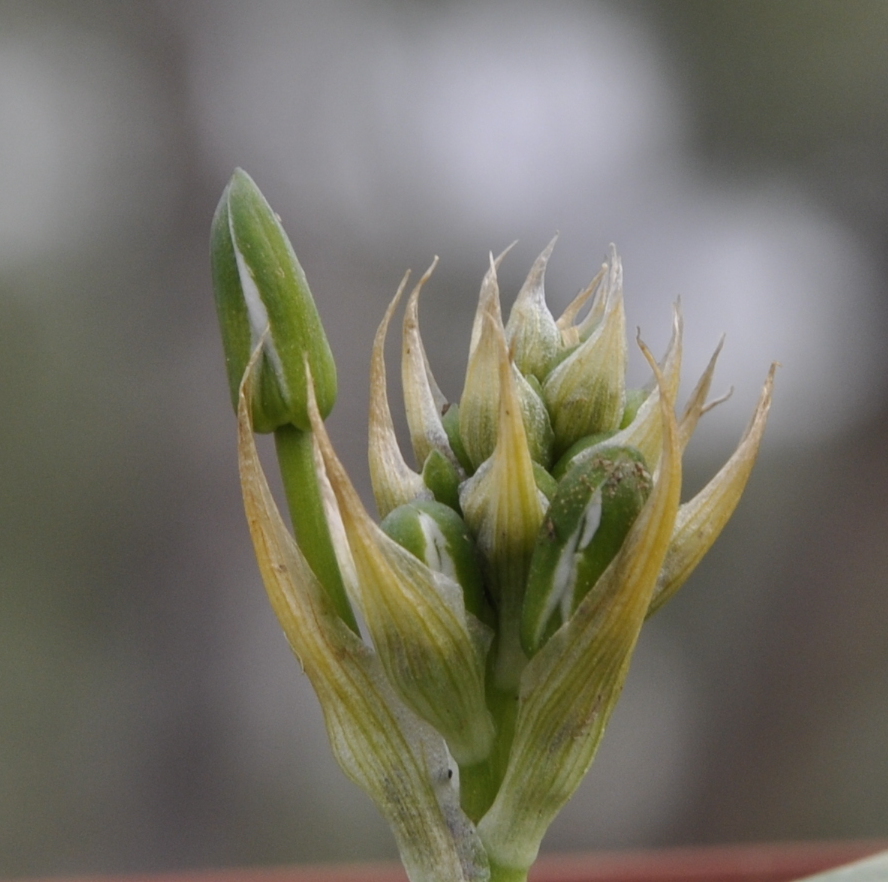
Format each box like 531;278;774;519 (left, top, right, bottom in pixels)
210;169;336;432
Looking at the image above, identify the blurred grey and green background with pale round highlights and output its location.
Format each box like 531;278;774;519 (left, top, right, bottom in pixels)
0;0;888;877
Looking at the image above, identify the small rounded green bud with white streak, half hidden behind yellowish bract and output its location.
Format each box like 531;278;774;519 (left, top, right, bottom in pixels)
379;501;489;620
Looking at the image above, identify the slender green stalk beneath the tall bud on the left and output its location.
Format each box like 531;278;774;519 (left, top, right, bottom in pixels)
274;426;360;634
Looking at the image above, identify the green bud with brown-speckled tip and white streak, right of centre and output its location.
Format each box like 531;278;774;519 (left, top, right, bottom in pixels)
521;447;651;656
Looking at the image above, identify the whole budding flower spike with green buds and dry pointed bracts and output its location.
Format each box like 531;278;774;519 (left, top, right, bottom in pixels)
212;171;774;882
